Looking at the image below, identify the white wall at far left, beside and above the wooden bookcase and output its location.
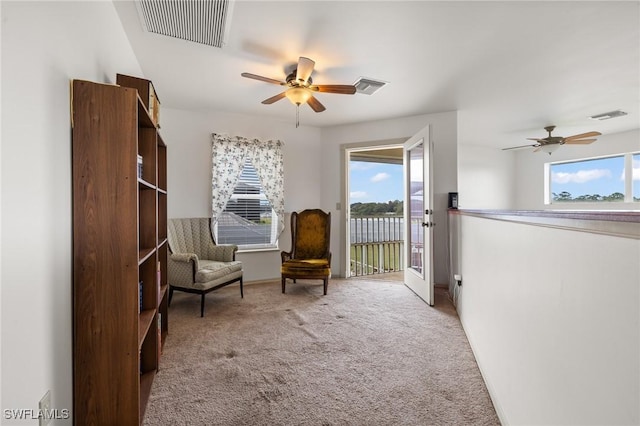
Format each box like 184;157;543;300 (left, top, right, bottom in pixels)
0;1;141;424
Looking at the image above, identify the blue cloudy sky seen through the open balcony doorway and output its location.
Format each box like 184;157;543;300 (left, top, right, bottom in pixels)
349;161;404;204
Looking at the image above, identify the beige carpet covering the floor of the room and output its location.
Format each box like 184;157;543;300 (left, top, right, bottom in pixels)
144;279;499;425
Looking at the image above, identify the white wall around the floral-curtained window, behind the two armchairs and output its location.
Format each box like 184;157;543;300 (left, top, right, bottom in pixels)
156;106;324;282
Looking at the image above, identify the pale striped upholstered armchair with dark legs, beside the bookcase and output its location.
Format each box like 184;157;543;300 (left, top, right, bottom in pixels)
167;217;244;317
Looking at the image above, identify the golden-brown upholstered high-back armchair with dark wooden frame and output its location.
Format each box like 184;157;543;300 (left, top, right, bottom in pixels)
280;209;331;295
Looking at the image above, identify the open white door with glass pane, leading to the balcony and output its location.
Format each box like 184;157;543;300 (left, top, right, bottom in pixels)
404;126;434;305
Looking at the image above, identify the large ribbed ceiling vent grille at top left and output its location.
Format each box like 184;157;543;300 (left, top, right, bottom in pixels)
136;0;233;48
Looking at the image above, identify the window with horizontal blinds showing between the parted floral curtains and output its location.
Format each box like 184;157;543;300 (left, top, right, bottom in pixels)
215;159;278;249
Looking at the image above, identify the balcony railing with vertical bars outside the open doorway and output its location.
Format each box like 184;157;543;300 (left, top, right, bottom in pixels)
349;215;404;276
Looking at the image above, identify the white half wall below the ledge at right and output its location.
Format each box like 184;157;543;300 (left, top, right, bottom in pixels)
456;215;640;425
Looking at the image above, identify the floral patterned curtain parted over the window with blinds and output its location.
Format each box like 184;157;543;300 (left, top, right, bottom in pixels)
211;133;284;235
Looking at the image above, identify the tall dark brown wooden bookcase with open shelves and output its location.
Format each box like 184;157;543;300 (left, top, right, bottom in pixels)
72;79;168;425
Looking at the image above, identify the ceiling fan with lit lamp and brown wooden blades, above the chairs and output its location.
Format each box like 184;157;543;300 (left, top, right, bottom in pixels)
241;56;356;127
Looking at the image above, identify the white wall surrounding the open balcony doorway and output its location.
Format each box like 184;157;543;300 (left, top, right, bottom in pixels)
322;112;457;284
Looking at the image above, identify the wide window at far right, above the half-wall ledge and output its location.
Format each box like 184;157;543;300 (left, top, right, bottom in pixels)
547;153;640;204
